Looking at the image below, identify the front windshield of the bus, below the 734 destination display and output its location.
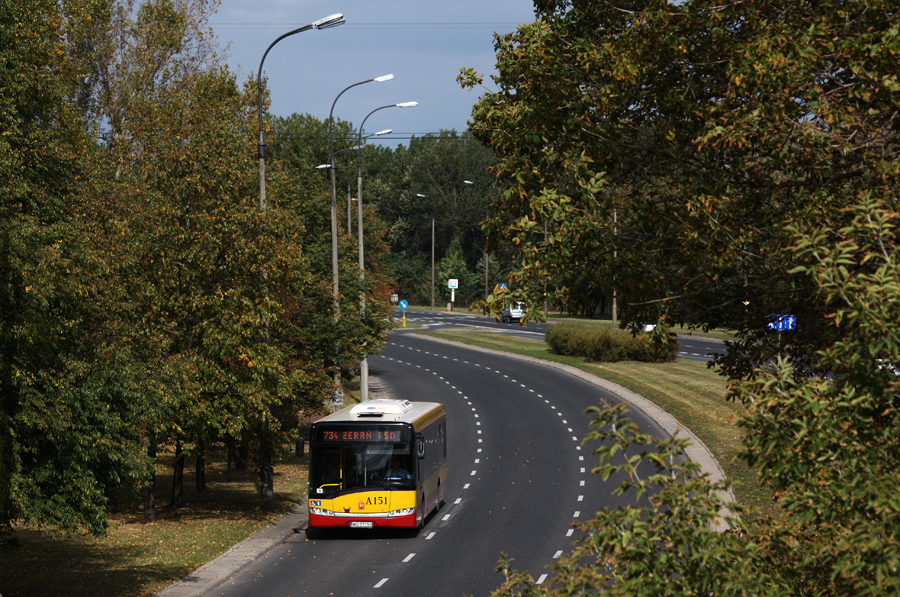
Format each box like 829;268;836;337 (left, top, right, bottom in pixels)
309;443;415;498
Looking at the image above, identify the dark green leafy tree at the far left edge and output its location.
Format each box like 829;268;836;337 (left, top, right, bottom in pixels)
0;2;144;533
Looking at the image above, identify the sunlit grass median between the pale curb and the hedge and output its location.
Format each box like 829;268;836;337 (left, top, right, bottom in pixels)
419;331;777;515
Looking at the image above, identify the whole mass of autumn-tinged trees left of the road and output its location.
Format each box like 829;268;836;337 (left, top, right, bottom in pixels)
0;0;390;534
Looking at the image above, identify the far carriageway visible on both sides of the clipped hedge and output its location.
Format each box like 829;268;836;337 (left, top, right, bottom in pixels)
394;309;725;362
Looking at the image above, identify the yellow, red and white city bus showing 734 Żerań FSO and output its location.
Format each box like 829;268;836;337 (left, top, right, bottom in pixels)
308;399;447;530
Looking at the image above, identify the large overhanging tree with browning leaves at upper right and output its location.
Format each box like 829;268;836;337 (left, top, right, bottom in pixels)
463;0;900;377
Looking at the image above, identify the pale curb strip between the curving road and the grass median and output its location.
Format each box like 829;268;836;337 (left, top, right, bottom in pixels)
416;336;736;532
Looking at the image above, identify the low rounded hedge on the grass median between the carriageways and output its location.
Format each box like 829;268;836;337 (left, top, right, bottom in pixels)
545;322;681;363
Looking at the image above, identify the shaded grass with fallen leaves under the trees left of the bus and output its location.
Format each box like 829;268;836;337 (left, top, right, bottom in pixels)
0;446;308;597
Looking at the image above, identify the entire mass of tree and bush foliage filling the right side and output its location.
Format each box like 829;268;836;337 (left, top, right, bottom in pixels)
472;0;900;597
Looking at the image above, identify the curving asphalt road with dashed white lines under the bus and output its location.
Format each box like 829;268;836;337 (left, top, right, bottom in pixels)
209;331;662;597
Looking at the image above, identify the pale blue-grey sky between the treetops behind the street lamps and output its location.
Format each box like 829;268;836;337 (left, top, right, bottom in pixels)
211;0;534;146
